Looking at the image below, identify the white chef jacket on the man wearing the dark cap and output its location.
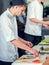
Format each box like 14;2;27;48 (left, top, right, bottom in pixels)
0;9;18;62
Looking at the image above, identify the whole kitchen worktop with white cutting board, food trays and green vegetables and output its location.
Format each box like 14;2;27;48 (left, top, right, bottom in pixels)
12;36;49;65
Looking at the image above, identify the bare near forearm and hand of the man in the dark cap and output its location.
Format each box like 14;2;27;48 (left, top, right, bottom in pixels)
11;39;39;56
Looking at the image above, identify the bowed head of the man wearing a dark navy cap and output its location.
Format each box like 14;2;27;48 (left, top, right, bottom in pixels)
9;0;26;16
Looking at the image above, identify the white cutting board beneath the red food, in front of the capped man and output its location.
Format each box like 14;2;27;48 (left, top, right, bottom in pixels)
12;55;42;65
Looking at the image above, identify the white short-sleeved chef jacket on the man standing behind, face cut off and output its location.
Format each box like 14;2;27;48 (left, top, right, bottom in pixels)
25;0;43;36
